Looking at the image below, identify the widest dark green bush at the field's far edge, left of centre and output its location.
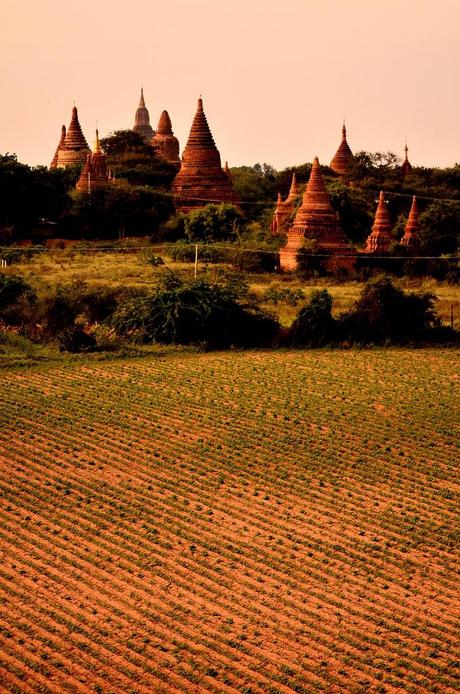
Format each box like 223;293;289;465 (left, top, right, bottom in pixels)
111;275;279;349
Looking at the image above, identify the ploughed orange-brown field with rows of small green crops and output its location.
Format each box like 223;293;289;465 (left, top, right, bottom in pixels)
0;349;459;694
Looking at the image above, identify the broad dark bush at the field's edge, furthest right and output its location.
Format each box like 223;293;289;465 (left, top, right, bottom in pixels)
340;278;440;344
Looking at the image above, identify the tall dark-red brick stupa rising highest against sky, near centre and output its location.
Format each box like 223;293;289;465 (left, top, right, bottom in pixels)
172;98;237;212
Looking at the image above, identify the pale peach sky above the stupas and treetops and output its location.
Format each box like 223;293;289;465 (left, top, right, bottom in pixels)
0;0;460;170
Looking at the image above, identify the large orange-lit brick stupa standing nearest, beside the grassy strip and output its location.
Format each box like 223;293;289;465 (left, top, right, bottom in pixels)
280;157;353;270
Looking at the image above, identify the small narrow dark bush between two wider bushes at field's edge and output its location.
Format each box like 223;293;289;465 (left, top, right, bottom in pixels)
290;289;337;347
